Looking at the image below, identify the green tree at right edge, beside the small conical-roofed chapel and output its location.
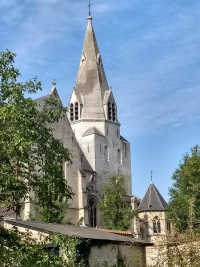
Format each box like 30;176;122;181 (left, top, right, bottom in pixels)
168;145;200;232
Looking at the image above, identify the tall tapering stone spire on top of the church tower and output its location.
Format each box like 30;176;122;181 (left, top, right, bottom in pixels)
75;16;109;119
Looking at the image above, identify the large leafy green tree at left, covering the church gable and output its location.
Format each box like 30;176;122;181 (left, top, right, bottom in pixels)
0;50;73;222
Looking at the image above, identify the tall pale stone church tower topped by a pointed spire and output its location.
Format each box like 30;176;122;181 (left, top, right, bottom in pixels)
68;16;131;226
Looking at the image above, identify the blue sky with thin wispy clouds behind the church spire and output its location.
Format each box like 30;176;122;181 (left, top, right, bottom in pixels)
0;0;200;200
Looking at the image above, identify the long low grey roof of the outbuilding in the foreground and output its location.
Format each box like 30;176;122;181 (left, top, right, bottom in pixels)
5;219;151;245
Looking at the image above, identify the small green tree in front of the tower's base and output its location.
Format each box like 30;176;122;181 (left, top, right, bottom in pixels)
98;175;136;231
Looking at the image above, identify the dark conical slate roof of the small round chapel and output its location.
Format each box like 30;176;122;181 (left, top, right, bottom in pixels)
138;183;168;211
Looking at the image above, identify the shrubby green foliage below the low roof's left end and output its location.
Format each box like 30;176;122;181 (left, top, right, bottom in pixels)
0;228;91;267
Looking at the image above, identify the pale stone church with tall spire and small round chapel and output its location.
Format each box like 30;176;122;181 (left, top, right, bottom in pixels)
21;13;171;245
